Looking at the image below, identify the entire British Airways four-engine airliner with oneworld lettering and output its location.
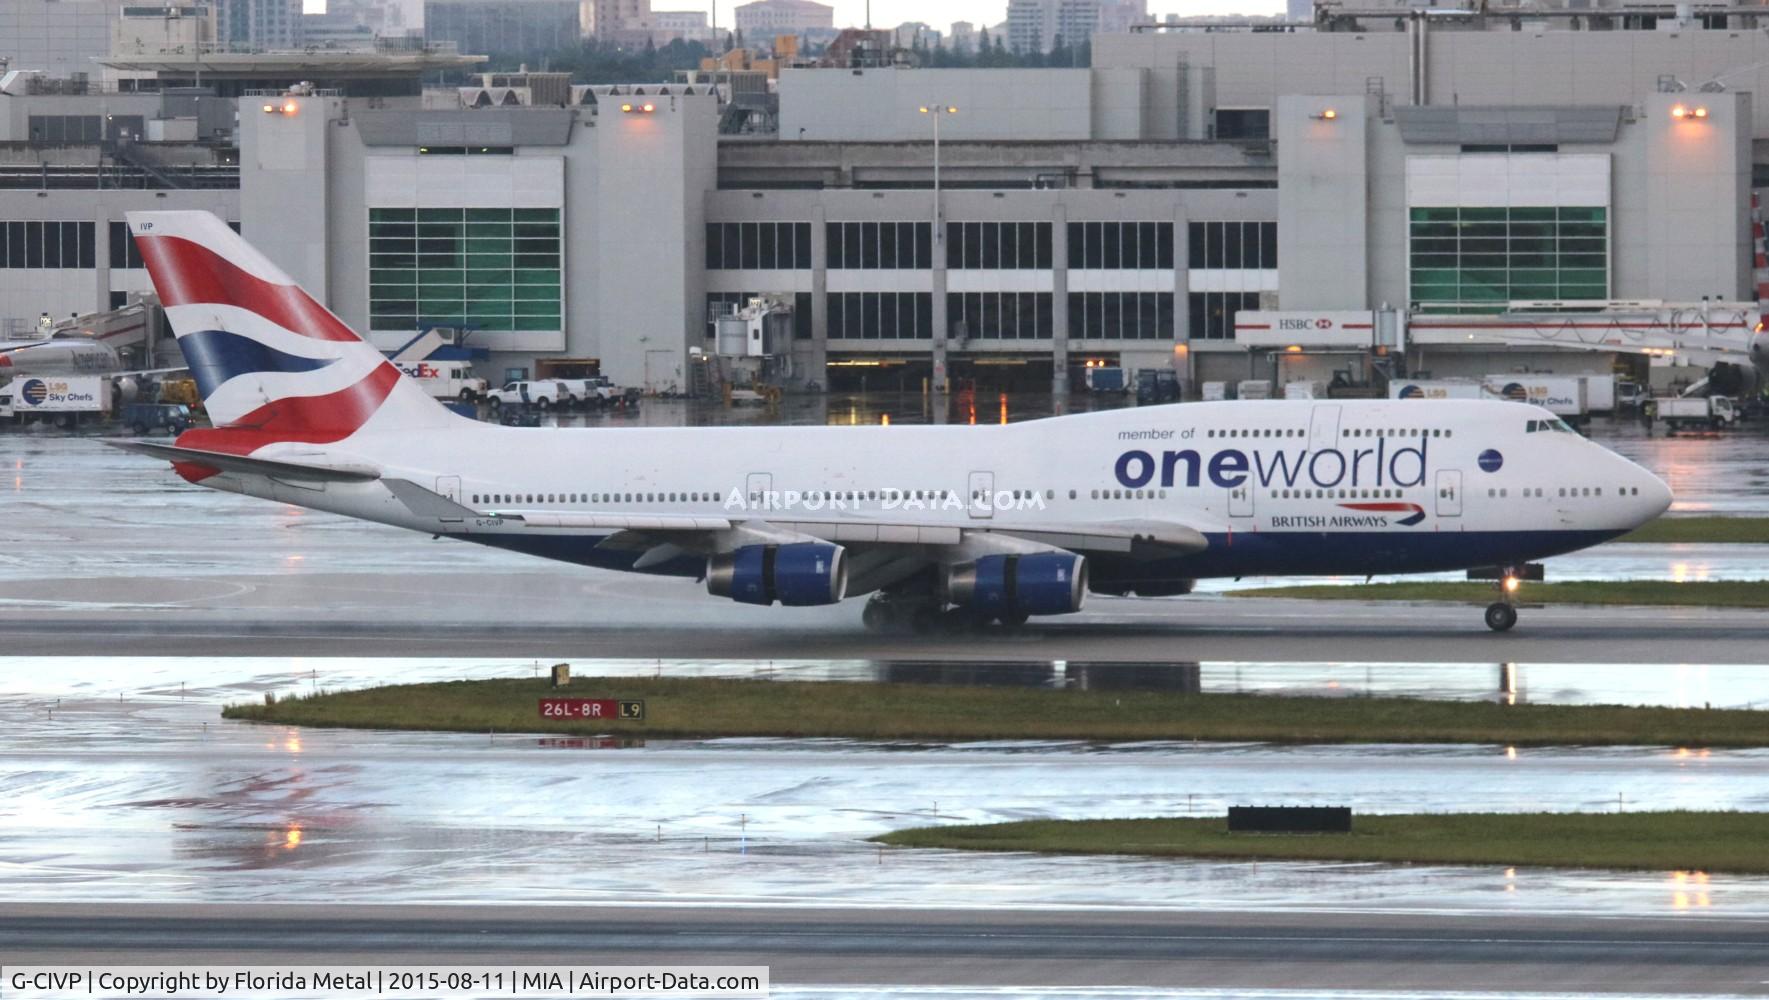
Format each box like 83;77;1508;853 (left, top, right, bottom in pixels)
120;212;1670;630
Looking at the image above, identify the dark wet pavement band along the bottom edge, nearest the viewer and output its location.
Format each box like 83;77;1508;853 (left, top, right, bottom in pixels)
13;906;1769;998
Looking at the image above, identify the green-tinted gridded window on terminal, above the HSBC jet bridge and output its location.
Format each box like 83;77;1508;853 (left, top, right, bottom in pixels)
1406;207;1610;312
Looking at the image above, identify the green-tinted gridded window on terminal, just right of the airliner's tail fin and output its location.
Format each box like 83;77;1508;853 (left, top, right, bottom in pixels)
368;209;564;331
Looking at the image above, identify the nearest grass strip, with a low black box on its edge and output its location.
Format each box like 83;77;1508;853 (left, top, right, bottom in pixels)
874;811;1769;874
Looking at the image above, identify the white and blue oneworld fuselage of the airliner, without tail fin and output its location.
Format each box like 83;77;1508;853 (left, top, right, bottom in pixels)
205;400;1670;579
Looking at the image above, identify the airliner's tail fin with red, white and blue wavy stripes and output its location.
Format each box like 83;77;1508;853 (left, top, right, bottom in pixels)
129;212;458;455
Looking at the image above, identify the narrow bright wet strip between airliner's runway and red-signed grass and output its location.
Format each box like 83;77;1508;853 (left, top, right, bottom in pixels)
0;657;1769;704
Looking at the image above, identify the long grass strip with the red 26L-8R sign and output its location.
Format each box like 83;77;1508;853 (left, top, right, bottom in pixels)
223;678;1769;747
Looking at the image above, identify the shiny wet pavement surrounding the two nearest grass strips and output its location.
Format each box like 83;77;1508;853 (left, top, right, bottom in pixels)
10;658;1769;915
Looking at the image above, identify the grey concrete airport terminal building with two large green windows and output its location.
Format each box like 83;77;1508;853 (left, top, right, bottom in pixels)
0;14;1769;389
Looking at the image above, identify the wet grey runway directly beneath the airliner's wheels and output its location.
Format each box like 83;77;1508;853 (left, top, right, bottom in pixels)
0;591;1769;664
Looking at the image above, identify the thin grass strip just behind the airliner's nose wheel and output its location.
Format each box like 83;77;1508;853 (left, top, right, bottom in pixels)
1228;581;1769;607
